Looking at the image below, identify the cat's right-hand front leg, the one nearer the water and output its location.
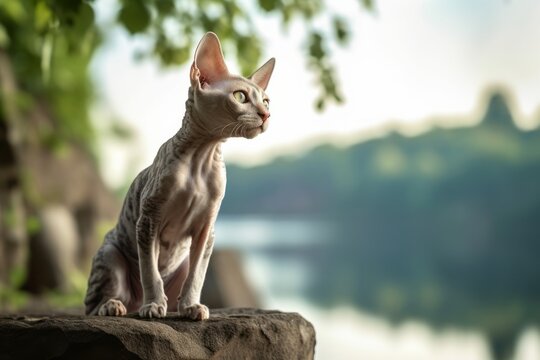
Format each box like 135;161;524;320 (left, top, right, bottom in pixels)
178;225;214;320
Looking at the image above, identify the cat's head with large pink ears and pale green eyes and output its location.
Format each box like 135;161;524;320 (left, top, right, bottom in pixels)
190;32;275;139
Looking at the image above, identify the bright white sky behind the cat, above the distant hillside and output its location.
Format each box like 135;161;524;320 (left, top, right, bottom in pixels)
93;0;540;185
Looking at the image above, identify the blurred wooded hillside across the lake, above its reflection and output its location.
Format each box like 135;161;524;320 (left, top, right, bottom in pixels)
221;95;540;216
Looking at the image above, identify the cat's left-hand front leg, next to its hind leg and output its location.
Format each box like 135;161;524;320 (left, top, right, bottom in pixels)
136;215;167;318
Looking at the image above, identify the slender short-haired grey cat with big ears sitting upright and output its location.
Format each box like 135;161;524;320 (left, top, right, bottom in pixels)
85;32;275;320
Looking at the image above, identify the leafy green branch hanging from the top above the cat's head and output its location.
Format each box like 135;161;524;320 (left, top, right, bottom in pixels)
113;0;373;110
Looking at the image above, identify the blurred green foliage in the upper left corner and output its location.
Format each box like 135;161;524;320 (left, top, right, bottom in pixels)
0;0;99;148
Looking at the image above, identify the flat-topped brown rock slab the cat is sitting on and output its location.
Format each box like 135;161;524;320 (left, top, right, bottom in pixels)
0;308;315;360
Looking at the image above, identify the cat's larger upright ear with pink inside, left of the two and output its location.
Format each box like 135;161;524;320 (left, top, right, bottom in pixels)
190;32;229;86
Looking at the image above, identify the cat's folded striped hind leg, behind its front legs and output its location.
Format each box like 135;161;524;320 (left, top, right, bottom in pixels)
84;233;132;316
